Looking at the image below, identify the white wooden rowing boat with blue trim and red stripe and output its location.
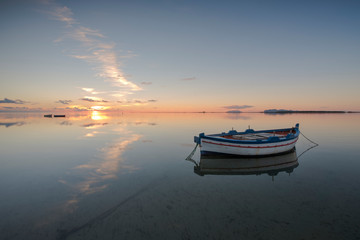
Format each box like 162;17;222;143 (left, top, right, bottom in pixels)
194;123;300;157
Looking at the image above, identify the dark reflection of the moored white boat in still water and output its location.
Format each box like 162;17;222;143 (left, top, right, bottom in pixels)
194;150;299;176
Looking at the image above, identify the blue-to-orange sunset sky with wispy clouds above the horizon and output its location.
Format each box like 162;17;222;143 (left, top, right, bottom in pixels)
0;0;360;112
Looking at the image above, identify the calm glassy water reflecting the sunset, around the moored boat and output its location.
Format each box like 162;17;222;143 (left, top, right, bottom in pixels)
0;112;360;239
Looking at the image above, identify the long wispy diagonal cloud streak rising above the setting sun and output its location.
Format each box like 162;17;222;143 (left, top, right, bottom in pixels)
45;1;141;100
